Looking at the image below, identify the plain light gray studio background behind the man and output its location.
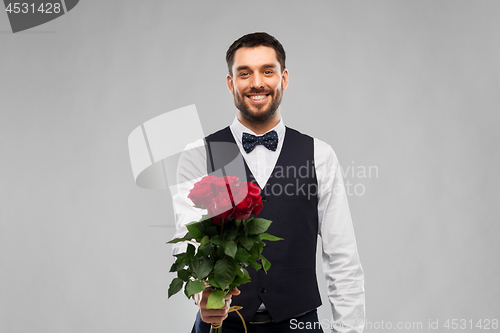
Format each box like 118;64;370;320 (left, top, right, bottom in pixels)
0;0;500;333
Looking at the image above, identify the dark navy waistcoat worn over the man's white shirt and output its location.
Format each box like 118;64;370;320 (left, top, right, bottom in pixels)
205;127;321;322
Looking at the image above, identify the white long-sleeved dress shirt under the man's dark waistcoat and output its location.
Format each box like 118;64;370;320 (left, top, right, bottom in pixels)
172;117;365;333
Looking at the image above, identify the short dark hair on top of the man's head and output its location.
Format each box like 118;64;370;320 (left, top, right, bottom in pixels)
226;32;286;76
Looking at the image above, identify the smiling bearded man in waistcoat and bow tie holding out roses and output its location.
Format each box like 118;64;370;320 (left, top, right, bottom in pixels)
174;33;365;333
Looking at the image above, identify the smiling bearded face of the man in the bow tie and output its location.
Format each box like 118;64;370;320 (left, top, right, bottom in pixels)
227;46;288;123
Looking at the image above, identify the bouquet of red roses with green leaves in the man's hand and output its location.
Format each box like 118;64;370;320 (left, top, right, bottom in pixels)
168;176;282;328
